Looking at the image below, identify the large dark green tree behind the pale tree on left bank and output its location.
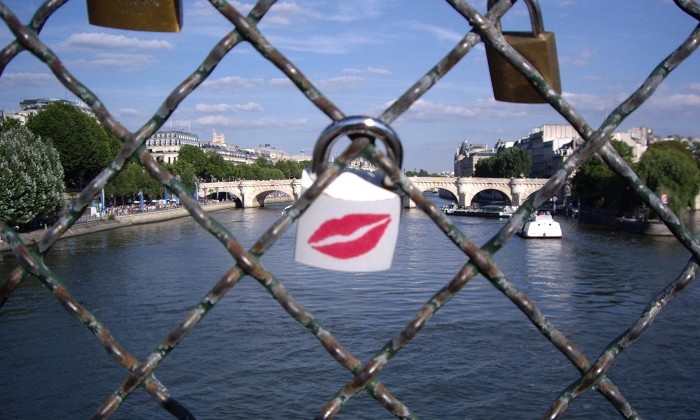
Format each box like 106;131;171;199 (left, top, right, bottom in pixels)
27;103;121;188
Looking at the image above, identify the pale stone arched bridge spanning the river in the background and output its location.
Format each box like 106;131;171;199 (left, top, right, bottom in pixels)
198;177;547;208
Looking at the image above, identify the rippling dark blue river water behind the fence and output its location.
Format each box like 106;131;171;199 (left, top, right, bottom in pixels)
0;198;700;419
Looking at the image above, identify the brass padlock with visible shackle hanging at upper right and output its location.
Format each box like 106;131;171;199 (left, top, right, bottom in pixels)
486;0;561;104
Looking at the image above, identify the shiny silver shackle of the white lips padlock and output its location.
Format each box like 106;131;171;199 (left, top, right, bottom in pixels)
311;115;403;174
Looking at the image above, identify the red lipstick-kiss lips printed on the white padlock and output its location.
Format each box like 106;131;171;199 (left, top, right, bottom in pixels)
308;213;391;260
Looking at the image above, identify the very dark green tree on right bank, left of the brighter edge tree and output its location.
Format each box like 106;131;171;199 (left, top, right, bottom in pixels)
571;140;640;212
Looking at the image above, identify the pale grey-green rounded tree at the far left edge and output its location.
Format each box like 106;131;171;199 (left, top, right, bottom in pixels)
0;124;65;223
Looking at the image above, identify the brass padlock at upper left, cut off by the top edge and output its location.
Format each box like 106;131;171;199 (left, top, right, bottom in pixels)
88;0;182;32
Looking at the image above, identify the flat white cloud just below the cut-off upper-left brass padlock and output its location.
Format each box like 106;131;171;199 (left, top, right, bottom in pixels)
61;32;175;50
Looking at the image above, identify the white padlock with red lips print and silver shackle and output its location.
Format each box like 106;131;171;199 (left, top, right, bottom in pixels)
294;117;403;272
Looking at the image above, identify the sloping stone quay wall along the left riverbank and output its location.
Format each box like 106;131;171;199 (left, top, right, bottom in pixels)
0;201;236;253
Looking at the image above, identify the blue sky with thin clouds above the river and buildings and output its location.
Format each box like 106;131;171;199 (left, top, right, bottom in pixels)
0;0;700;171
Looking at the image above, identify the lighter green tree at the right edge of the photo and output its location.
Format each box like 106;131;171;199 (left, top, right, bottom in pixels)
638;141;700;217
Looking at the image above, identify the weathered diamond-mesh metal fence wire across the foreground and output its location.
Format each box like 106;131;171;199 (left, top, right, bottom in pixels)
0;0;700;418
